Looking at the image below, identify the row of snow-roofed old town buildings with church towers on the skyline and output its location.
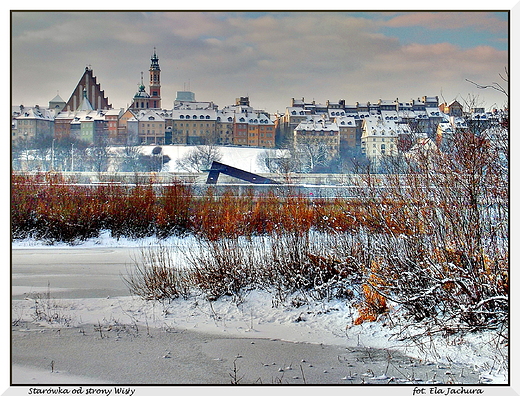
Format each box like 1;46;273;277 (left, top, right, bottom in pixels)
11;48;508;168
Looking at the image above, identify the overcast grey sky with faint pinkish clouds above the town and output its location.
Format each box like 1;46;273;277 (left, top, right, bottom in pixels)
11;11;509;113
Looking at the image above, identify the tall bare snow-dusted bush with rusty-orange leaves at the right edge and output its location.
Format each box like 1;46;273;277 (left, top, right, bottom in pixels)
359;131;509;332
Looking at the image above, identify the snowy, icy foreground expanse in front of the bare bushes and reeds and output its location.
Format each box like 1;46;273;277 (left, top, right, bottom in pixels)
11;240;509;385
